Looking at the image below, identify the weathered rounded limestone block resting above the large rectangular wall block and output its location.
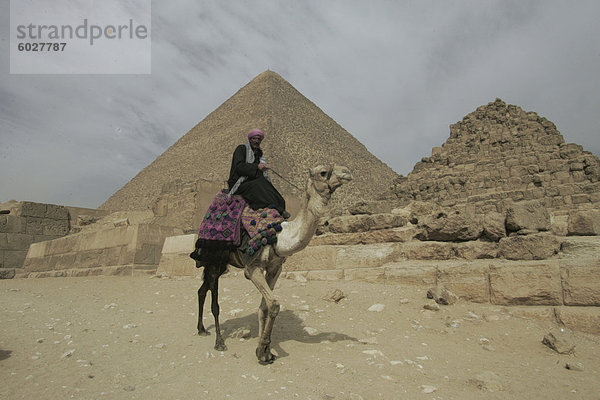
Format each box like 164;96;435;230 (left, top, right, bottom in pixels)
498;234;561;260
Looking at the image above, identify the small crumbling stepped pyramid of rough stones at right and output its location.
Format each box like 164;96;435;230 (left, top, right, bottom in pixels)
387;99;600;215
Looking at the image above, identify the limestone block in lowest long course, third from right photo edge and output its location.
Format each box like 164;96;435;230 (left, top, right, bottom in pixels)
437;263;490;303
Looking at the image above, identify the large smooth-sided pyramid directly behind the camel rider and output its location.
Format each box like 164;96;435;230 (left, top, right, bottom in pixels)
100;71;398;211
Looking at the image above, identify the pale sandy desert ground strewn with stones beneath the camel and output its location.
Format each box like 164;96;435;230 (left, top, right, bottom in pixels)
0;271;600;400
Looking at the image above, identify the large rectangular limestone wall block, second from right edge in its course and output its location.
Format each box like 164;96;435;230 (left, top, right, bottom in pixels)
489;261;563;305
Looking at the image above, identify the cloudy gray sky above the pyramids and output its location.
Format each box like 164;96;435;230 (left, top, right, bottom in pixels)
0;0;600;208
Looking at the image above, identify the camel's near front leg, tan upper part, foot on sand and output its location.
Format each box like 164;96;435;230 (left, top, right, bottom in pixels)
246;266;279;364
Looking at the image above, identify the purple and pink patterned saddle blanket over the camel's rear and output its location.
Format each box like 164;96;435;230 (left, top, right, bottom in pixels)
196;192;246;249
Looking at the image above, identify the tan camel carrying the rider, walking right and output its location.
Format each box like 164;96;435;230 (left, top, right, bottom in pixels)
197;165;352;364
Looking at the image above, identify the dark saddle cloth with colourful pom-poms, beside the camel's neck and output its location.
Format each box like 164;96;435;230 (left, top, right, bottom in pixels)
242;207;284;255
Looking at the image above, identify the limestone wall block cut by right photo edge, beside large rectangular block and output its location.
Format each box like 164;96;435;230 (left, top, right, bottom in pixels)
560;258;600;306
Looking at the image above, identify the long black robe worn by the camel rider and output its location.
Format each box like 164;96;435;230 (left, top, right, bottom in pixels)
227;144;285;214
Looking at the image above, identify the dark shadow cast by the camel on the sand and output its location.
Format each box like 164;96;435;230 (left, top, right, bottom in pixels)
207;310;358;357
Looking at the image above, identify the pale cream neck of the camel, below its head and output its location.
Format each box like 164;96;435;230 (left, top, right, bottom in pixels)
275;189;329;257
